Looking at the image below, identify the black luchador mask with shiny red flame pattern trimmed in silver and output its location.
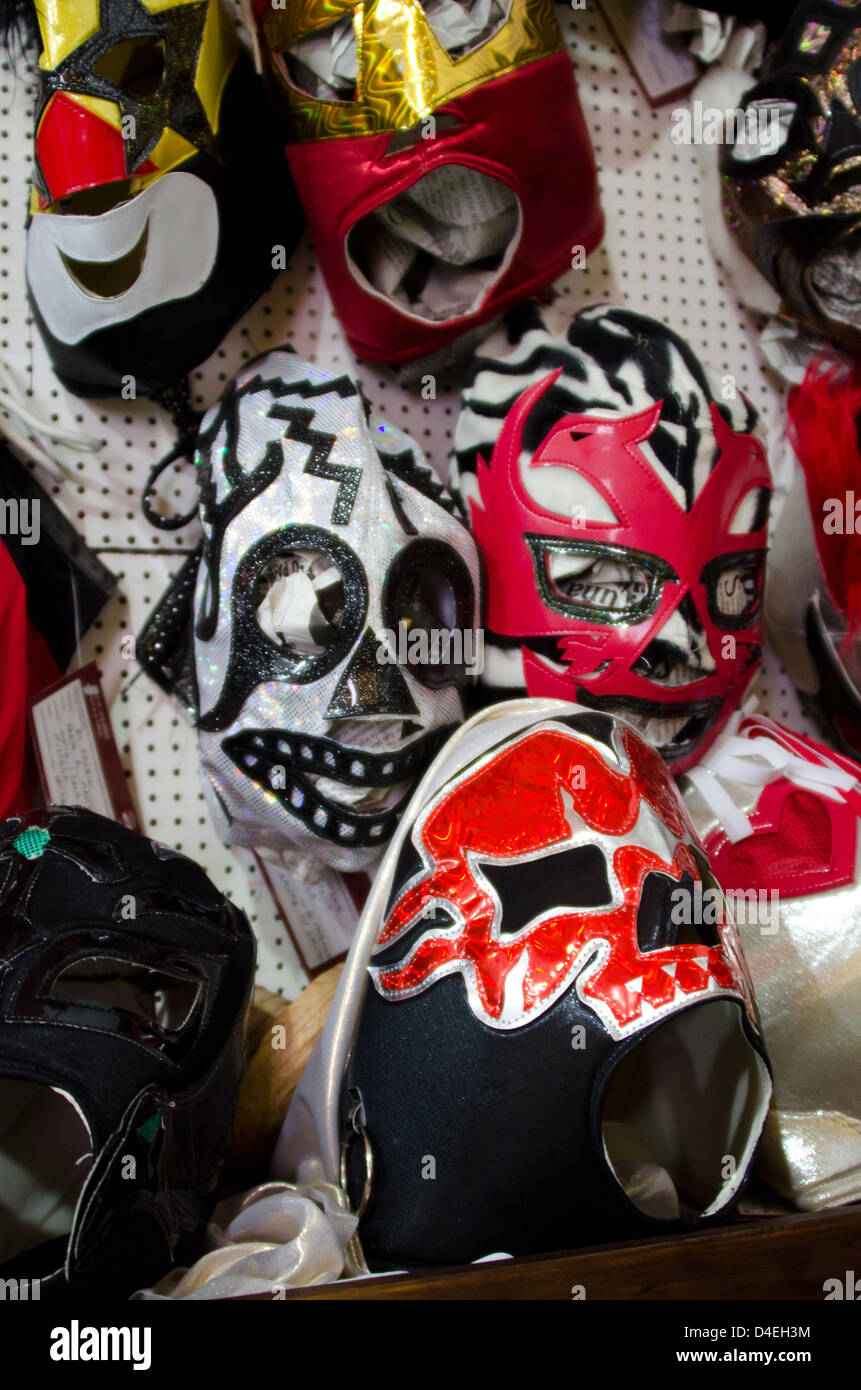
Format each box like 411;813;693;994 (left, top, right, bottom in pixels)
274;701;771;1268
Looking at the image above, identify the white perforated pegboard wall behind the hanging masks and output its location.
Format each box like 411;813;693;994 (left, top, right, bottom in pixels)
0;3;814;998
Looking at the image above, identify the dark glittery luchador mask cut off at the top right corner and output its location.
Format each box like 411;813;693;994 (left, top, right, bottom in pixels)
721;0;861;352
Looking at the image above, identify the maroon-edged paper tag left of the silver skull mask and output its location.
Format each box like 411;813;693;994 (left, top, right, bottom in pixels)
29;662;140;830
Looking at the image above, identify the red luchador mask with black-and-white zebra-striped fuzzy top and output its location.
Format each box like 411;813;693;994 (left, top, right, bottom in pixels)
453;306;771;771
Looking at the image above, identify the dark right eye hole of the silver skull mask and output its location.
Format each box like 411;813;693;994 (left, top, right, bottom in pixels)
383;541;476;687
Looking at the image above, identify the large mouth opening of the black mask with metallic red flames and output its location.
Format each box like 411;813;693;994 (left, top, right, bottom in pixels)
601;999;771;1220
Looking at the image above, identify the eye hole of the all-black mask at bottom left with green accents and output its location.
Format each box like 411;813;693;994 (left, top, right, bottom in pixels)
49;956;200;1033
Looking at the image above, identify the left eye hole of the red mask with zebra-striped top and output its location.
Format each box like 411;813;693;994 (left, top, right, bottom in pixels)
526;535;676;623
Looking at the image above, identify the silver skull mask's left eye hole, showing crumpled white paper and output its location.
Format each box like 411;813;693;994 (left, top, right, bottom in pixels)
255;550;345;656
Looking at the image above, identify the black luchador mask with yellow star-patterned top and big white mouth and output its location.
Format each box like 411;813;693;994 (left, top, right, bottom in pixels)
26;0;300;395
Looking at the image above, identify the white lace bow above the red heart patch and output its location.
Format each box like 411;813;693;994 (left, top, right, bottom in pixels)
686;699;857;844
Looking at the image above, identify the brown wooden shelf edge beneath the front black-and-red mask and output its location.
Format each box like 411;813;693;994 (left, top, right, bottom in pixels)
274;1205;861;1301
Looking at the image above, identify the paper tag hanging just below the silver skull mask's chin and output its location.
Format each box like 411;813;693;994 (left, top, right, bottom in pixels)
255;855;370;977
